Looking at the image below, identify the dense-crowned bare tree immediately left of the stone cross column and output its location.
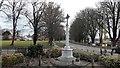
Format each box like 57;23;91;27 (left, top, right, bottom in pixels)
43;2;64;45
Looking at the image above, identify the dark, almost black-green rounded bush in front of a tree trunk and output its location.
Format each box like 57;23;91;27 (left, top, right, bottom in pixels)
27;44;44;57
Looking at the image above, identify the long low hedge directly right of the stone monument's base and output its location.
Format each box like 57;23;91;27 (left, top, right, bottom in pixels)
73;49;100;61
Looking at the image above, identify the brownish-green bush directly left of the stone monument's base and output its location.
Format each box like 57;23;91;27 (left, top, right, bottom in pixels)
46;48;62;58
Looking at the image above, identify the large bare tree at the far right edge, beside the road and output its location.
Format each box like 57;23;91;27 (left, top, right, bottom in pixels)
99;1;120;47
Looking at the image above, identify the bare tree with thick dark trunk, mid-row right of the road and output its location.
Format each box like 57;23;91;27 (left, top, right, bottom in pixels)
81;8;98;43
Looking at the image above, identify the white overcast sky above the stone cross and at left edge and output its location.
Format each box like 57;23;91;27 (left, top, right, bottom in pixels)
0;0;103;35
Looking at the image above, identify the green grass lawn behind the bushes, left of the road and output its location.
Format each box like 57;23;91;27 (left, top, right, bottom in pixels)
0;40;64;49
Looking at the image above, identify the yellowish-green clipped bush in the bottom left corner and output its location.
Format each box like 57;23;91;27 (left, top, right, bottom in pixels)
1;53;24;66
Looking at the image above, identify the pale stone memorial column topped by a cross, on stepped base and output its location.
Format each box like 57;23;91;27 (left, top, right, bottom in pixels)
58;14;75;65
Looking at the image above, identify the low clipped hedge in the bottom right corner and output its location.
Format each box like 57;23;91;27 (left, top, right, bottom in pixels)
99;55;120;68
